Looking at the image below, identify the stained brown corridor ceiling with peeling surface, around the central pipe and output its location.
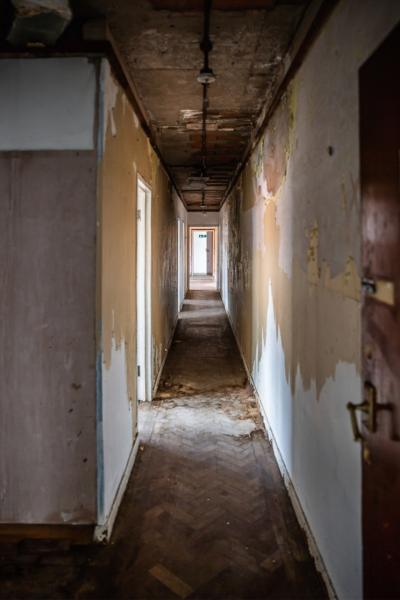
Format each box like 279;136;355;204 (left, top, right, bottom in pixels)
72;0;308;210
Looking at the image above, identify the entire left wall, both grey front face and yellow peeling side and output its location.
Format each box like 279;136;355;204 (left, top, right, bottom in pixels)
0;57;187;537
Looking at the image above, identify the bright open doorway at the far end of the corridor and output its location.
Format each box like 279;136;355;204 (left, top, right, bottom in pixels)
189;227;218;290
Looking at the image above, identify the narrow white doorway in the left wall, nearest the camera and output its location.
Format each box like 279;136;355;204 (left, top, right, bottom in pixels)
136;177;152;402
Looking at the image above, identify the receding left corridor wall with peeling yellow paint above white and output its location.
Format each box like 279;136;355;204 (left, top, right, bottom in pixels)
98;60;186;521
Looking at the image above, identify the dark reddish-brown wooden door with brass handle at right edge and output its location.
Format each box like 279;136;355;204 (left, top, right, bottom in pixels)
360;27;400;598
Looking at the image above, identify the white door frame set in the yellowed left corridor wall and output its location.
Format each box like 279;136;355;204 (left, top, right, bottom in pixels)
135;174;153;402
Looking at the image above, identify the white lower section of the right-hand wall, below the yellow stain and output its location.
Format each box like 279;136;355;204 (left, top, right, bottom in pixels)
252;284;362;599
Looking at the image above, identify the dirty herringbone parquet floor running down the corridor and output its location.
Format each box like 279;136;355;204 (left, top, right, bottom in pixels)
0;291;327;600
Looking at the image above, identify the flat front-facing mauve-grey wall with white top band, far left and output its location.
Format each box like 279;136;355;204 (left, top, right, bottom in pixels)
0;58;97;525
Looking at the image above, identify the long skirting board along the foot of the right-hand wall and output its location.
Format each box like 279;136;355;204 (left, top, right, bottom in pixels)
224;304;338;600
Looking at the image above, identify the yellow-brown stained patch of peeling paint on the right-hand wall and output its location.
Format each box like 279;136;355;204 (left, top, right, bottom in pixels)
223;94;360;392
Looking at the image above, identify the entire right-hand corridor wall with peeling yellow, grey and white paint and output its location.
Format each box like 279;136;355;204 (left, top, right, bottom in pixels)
220;0;400;598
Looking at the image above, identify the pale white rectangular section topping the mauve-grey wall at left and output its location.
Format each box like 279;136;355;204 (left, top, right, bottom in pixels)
0;57;96;150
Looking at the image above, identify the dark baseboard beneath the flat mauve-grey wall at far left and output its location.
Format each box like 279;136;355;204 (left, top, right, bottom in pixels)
0;523;95;545
